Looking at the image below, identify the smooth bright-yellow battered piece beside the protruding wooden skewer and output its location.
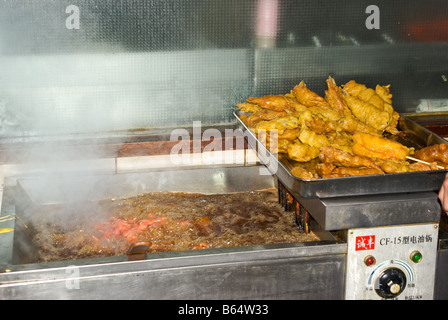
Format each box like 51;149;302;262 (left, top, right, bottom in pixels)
353;133;411;160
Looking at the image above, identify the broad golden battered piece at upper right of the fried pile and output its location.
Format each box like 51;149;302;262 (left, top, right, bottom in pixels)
343;93;391;132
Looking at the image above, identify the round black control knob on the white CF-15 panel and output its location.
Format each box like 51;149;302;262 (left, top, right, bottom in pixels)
375;268;406;299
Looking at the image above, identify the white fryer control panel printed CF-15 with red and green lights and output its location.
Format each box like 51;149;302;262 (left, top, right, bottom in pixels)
345;223;439;300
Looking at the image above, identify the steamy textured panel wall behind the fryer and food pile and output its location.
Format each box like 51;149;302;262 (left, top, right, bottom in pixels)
0;0;448;136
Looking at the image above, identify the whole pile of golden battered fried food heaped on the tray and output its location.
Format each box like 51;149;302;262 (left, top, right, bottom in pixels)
237;77;448;179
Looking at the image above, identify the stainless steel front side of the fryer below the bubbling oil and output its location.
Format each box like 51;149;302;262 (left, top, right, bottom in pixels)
0;244;346;300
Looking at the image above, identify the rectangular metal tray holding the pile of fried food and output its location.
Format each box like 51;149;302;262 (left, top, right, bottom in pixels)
234;111;447;198
